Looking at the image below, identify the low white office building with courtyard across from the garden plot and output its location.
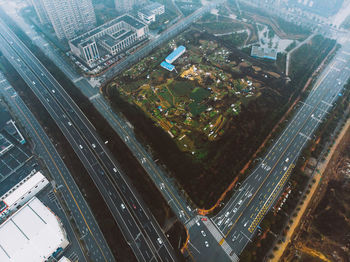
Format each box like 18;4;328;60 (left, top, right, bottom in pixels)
69;15;149;64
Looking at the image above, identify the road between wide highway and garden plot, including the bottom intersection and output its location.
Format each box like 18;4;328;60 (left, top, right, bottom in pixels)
0;3;238;261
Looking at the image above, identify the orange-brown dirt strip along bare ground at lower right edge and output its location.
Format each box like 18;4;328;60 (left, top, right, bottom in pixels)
269;120;350;262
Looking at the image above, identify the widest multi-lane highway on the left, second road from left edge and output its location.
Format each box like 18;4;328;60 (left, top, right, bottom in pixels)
0;17;175;261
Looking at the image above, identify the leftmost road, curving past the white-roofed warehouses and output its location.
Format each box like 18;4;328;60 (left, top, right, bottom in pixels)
0;74;114;262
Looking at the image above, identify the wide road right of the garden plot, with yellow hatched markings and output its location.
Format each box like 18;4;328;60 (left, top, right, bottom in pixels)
211;42;350;256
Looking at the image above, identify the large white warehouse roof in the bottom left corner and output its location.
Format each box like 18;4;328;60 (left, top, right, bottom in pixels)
0;197;68;262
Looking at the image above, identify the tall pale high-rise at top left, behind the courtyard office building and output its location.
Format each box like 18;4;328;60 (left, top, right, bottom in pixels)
32;0;96;39
